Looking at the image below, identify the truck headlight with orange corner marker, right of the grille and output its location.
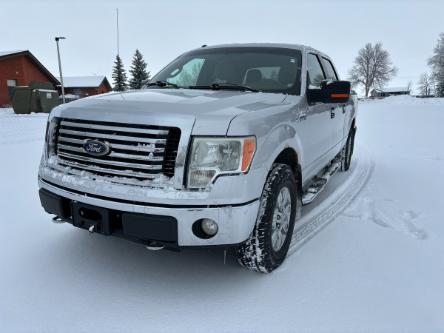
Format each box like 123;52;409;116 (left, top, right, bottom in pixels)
187;136;256;188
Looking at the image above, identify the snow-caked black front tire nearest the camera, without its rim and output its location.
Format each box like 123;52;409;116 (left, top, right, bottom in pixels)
236;163;302;273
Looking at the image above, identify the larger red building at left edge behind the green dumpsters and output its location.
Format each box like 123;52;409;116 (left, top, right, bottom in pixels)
0;50;60;107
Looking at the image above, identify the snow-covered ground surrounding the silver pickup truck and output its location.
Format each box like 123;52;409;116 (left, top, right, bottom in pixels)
0;97;444;332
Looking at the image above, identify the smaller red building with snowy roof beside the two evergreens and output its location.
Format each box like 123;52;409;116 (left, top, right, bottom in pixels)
59;76;111;98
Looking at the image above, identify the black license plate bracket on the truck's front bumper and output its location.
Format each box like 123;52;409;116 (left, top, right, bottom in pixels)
72;201;112;235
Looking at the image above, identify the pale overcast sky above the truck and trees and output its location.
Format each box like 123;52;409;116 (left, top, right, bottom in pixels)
0;0;444;94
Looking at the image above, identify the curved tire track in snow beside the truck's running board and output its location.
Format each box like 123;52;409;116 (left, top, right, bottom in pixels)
288;148;374;256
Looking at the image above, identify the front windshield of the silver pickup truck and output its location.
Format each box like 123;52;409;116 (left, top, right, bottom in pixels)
150;47;302;95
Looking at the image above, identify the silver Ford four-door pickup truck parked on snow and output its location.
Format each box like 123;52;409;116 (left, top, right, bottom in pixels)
39;44;356;273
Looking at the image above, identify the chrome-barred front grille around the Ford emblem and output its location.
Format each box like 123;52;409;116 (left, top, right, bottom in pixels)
53;119;180;182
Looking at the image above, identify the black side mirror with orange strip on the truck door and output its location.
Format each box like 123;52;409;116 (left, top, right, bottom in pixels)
307;81;351;104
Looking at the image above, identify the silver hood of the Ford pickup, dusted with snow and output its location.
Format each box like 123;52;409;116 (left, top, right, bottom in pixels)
51;88;285;135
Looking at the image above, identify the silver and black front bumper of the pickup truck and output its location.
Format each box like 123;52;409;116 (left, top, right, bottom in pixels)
39;179;259;247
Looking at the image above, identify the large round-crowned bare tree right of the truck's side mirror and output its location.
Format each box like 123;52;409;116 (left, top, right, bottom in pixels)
349;43;397;97
